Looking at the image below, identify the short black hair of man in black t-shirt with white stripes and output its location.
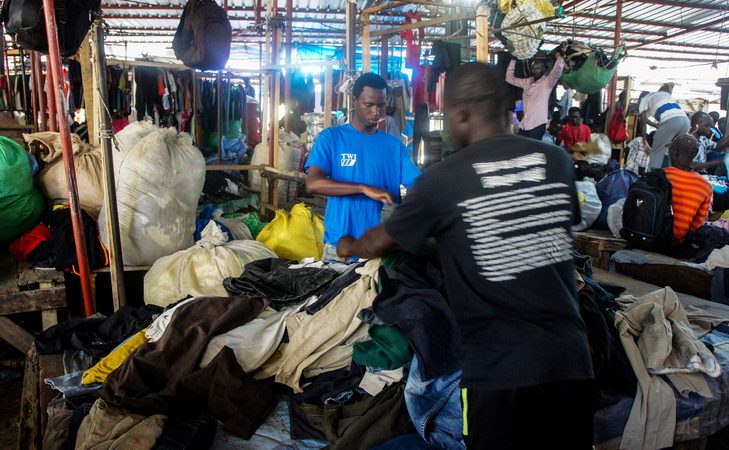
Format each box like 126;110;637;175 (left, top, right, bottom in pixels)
443;62;508;120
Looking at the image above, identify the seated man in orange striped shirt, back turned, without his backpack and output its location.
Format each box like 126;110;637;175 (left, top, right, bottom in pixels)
663;134;712;243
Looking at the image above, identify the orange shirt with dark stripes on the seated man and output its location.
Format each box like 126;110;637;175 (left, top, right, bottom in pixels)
663;167;712;242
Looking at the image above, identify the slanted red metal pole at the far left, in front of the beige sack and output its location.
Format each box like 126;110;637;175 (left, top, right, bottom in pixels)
43;0;95;316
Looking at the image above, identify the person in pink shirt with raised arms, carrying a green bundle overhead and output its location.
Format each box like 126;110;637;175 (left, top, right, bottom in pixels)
506;44;566;140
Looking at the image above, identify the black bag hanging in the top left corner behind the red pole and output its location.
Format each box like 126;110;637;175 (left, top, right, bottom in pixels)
0;0;101;57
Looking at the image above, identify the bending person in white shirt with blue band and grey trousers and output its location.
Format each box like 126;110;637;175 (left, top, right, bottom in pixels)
638;83;689;170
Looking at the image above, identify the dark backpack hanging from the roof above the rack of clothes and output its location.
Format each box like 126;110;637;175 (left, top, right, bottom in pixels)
172;0;233;70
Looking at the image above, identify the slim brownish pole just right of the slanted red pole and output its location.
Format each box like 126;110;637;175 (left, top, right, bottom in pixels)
93;12;127;311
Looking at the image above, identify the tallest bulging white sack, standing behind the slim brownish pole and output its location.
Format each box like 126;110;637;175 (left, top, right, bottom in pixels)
99;125;205;265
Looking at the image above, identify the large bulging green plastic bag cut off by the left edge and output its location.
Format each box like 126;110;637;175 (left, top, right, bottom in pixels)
0;136;44;243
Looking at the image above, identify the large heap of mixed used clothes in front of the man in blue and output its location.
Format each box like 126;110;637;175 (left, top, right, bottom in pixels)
37;255;464;449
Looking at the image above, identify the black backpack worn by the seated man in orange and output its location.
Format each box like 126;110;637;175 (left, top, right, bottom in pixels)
620;170;673;251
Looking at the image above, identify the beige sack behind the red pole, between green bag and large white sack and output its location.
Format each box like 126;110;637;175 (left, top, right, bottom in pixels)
23;132;104;218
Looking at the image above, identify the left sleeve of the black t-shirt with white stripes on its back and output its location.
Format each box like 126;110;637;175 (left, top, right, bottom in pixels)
384;174;442;254
